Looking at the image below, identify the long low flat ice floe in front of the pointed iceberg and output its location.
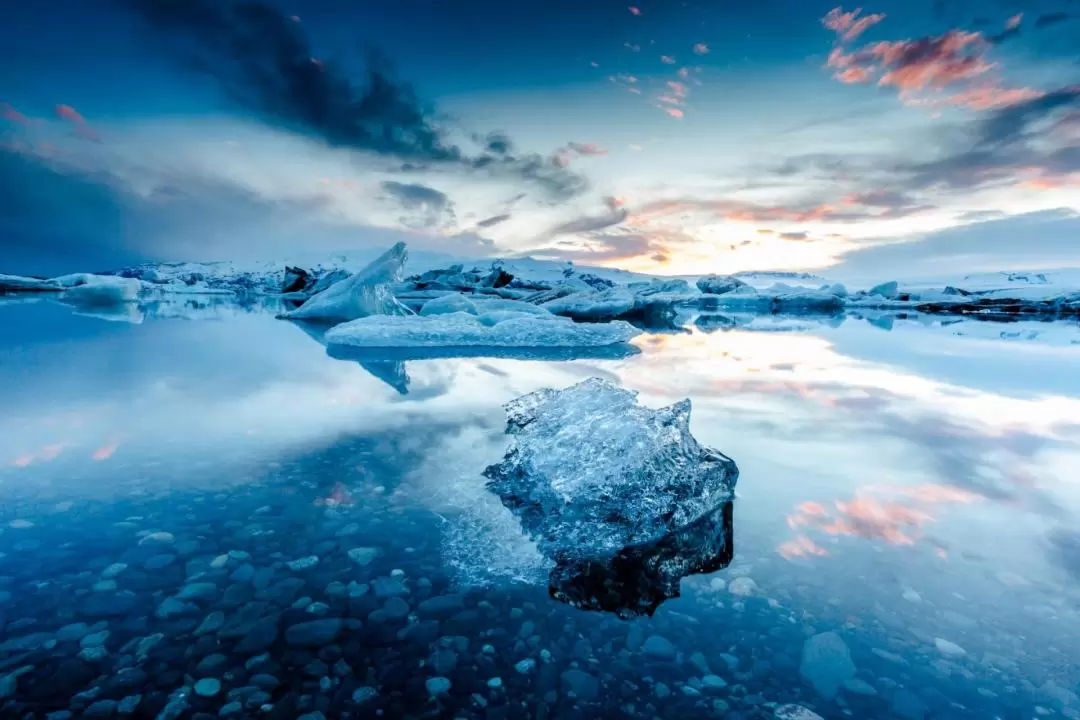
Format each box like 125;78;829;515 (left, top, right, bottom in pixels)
325;310;640;348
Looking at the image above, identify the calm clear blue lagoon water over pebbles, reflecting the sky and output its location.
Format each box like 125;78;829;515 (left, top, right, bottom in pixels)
0;300;1080;718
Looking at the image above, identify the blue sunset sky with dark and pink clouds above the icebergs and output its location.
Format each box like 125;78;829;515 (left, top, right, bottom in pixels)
0;0;1080;279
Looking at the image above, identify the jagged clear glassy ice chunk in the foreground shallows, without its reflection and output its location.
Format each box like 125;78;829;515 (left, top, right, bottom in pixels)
484;379;739;560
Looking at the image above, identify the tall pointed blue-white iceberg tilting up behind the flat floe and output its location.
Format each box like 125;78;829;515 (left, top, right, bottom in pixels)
283;243;413;323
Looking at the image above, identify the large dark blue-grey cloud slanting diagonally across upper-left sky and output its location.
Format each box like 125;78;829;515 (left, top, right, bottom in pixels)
121;0;588;200
